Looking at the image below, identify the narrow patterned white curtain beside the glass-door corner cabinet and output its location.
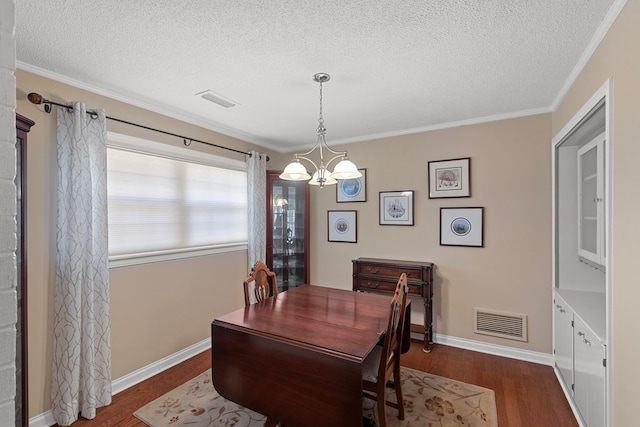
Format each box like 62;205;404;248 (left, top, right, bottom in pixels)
247;151;267;271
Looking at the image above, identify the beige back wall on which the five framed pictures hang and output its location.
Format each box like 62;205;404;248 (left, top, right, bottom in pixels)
304;114;551;354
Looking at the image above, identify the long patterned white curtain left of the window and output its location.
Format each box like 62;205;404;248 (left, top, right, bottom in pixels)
51;102;111;426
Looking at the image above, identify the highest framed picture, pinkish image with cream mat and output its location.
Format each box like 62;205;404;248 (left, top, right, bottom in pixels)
428;157;471;199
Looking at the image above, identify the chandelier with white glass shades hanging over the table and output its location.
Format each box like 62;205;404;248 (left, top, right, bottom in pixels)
280;73;362;188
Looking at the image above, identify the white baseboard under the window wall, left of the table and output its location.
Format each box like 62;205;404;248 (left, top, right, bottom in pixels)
29;338;211;427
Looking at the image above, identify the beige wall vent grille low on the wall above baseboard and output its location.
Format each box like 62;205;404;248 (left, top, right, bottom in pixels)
473;308;527;341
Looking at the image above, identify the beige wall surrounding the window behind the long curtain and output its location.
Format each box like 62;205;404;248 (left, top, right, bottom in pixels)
16;71;277;417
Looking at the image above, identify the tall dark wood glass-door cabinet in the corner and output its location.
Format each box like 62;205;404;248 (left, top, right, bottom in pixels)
267;171;309;291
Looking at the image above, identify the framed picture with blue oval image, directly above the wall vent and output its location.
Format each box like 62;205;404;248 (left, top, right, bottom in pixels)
440;208;484;248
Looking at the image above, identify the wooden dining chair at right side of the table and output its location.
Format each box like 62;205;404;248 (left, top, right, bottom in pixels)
362;273;408;427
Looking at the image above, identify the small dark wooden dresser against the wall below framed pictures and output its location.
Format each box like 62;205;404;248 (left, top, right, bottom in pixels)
352;258;433;353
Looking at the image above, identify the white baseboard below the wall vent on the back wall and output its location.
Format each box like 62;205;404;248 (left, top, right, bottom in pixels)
411;331;553;366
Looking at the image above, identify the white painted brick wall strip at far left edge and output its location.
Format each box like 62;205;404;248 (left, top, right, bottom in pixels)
0;0;17;420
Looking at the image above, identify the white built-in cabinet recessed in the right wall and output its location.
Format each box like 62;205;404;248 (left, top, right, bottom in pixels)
552;80;613;427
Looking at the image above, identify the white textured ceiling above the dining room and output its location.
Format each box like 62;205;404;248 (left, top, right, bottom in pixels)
16;0;621;152
